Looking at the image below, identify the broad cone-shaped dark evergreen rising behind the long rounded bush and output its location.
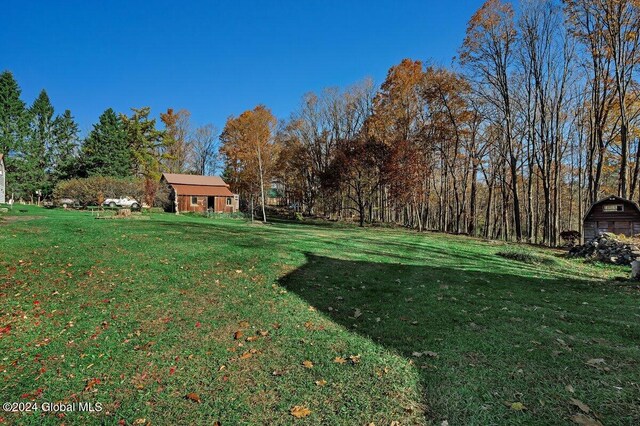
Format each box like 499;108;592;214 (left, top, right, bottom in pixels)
80;108;133;177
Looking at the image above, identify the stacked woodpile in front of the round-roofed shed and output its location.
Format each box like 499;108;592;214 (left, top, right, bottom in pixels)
569;232;640;265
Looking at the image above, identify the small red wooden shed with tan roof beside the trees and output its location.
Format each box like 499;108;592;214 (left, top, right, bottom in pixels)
162;173;239;213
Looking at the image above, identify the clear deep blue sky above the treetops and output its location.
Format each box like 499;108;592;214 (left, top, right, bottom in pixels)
0;0;483;134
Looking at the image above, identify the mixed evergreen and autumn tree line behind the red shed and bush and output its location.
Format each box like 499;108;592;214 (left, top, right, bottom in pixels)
0;71;220;204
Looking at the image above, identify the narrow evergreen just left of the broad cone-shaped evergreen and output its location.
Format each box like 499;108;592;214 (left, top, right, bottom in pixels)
48;110;79;182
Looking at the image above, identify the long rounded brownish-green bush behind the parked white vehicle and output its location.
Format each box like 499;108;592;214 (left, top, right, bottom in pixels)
53;176;144;207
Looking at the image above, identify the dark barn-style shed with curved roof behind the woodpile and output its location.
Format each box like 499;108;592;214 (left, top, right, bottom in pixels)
582;195;640;241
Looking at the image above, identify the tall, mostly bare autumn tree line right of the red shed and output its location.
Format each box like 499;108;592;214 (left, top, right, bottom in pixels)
221;0;640;245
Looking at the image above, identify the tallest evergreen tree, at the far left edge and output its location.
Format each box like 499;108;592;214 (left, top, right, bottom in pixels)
0;71;29;195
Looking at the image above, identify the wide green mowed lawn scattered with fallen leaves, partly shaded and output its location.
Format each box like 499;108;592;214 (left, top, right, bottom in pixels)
0;208;640;425
